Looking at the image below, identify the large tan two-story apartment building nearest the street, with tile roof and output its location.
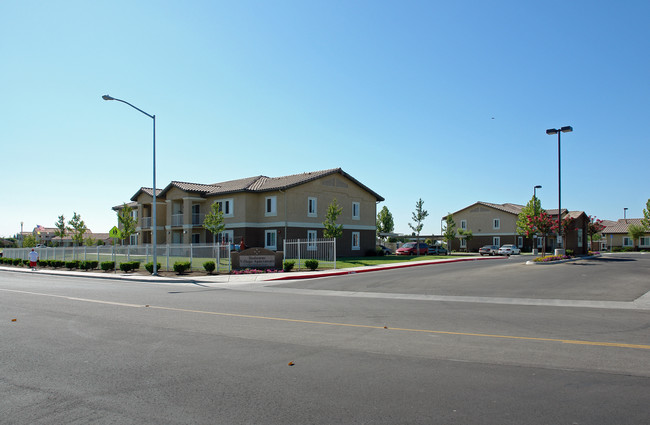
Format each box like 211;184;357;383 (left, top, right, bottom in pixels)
113;168;384;256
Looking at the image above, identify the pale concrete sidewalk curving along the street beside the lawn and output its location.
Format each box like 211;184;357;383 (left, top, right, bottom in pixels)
0;253;507;284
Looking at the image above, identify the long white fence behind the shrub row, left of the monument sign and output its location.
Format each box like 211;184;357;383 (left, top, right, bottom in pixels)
3;244;231;272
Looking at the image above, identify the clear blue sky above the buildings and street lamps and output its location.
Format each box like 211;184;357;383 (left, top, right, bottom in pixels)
0;0;650;236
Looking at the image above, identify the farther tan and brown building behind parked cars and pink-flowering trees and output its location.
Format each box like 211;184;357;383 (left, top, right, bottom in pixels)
443;201;589;254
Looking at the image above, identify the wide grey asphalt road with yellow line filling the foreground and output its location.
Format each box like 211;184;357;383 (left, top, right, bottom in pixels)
0;255;650;424
